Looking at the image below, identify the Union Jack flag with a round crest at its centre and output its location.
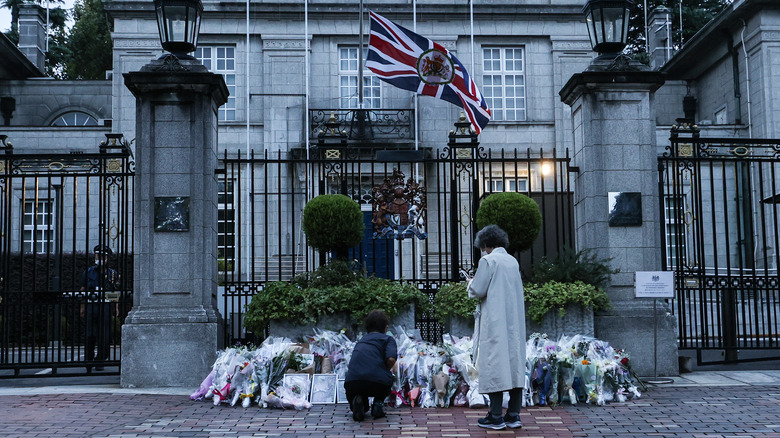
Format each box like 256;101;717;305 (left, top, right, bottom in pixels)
366;12;490;134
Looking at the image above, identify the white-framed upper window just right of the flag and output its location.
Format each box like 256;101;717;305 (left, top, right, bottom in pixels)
482;47;526;121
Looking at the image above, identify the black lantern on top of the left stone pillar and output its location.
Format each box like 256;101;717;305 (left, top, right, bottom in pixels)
154;0;203;59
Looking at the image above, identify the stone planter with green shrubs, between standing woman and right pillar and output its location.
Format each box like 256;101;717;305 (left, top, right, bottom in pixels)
525;248;618;339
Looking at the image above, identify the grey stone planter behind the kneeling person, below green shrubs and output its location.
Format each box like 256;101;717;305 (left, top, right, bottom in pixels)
268;305;415;341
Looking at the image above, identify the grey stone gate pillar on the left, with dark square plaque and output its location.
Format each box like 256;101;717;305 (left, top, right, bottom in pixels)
121;55;228;387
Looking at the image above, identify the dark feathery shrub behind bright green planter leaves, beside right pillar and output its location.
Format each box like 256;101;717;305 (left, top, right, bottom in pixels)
531;248;619;288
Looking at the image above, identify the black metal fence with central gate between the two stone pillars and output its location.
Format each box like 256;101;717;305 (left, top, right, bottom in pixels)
217;143;574;345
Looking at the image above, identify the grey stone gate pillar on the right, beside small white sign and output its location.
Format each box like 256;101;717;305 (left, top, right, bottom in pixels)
560;57;678;376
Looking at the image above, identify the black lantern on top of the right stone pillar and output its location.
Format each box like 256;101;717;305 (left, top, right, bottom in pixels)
582;0;634;59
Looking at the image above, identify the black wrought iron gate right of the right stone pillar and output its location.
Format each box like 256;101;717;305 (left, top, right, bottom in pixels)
658;126;780;364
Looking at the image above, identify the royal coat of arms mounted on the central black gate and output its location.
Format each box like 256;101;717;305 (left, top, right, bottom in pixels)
371;169;428;239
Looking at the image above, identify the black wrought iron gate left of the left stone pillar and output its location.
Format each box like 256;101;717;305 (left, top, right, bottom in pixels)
0;134;135;377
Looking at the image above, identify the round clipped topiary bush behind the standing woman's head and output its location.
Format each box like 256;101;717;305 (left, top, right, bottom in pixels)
477;192;542;253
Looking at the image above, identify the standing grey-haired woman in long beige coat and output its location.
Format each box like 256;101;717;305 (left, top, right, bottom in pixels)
468;225;526;430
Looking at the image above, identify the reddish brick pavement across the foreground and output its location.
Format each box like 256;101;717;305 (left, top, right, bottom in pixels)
0;386;780;438
